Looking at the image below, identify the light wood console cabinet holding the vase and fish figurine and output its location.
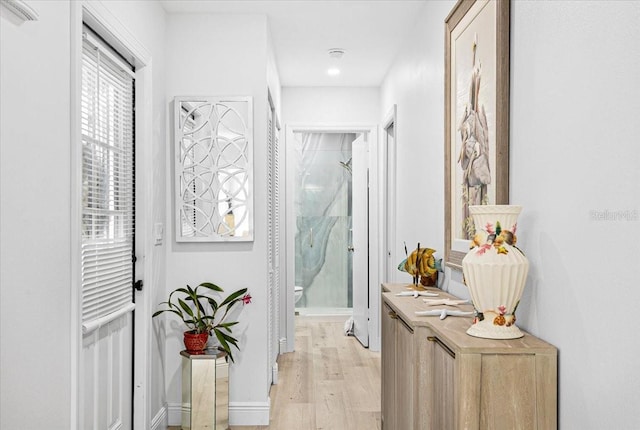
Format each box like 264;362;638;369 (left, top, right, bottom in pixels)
381;284;557;430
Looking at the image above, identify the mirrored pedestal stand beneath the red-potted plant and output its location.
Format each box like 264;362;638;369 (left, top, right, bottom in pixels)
180;350;229;430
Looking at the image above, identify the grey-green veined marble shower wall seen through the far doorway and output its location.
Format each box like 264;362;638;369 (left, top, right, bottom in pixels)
295;133;356;309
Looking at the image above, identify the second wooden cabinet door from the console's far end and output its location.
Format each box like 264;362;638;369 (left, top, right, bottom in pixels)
396;318;416;430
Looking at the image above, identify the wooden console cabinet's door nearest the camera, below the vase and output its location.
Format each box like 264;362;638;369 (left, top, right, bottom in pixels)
432;340;455;430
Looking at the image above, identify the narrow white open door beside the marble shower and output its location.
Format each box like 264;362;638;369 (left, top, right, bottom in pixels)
350;133;369;346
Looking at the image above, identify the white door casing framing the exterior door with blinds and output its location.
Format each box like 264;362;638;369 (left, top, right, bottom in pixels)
69;1;154;430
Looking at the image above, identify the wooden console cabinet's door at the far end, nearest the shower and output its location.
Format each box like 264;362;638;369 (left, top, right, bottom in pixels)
380;304;397;430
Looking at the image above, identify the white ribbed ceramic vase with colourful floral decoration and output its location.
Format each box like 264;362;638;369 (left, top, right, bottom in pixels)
462;205;529;339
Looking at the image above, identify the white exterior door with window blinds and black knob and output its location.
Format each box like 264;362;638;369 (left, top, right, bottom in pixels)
79;28;135;430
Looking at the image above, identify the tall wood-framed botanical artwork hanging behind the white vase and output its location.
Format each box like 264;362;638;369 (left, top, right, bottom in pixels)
445;0;510;269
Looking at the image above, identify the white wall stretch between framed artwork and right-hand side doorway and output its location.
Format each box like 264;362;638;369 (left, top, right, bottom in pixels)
378;1;455;282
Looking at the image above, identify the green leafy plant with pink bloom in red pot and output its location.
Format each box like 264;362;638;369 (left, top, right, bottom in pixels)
153;282;251;361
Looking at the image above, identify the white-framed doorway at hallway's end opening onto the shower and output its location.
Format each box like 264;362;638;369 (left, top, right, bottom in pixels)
284;126;379;352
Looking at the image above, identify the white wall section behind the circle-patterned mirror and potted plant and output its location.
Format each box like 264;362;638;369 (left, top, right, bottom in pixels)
165;14;274;425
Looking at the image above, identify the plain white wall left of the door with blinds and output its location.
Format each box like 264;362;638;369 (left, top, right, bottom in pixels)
0;2;71;430
